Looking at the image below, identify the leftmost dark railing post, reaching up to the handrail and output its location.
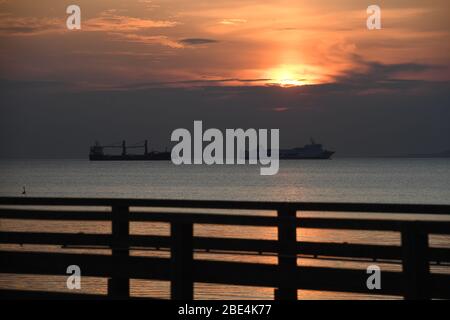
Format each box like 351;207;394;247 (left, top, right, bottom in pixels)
108;206;130;299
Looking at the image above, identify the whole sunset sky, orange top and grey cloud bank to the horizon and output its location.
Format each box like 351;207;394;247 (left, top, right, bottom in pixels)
0;0;450;158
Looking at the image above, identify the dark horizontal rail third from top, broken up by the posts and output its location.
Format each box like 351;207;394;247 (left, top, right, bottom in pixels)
0;232;408;262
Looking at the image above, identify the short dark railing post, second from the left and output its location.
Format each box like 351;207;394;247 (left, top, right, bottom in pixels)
170;222;194;300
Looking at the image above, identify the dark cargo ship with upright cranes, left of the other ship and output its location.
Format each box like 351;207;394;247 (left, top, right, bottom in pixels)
89;140;171;161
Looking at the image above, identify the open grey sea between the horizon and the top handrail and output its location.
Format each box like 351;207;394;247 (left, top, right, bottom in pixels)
0;159;450;204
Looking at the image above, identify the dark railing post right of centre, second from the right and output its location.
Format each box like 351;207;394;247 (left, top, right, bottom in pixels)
275;207;297;300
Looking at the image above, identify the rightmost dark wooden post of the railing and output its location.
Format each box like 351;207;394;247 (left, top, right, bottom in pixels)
402;222;430;300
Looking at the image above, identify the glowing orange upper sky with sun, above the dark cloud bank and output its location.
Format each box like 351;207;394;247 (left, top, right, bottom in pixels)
0;0;450;87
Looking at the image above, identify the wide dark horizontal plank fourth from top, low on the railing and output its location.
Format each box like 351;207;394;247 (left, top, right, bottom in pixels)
4;251;450;297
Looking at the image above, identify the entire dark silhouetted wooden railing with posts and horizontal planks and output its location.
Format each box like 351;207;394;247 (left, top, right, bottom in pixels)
0;197;450;300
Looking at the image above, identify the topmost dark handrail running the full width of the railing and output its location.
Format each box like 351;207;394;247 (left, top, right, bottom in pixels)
0;197;450;215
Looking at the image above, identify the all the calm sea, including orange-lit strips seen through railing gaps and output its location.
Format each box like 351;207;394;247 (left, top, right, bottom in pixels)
0;159;450;299
